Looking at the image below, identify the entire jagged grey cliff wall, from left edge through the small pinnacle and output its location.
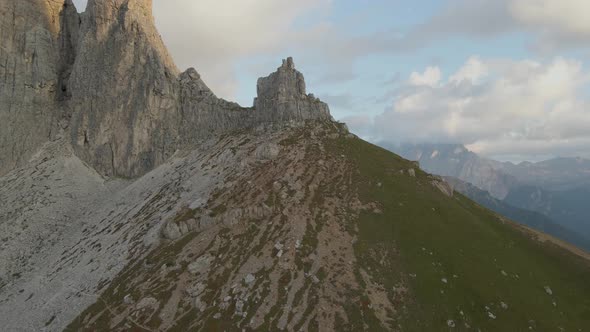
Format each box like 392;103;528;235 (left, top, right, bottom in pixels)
0;0;331;178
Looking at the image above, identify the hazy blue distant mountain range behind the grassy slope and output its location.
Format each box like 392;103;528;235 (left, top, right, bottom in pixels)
381;143;590;250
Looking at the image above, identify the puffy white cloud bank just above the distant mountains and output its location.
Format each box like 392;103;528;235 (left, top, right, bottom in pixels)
366;58;590;160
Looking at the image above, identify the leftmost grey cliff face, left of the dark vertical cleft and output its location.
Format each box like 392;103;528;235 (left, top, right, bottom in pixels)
0;0;78;175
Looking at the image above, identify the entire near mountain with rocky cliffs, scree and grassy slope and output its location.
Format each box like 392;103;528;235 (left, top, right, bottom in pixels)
0;0;590;331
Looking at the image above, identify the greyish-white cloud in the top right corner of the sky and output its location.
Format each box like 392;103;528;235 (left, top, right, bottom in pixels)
402;0;590;54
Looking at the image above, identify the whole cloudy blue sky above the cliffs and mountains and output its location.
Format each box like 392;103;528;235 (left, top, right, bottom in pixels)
74;0;590;161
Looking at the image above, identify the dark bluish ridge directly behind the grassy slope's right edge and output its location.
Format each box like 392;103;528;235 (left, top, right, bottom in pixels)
444;177;590;252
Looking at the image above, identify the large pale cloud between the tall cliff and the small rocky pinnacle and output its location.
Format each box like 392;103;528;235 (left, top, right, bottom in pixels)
154;0;329;98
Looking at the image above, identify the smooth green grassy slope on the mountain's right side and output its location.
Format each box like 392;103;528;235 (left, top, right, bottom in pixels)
331;135;590;331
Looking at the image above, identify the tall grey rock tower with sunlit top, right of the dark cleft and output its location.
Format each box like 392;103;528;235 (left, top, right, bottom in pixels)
69;0;178;177
